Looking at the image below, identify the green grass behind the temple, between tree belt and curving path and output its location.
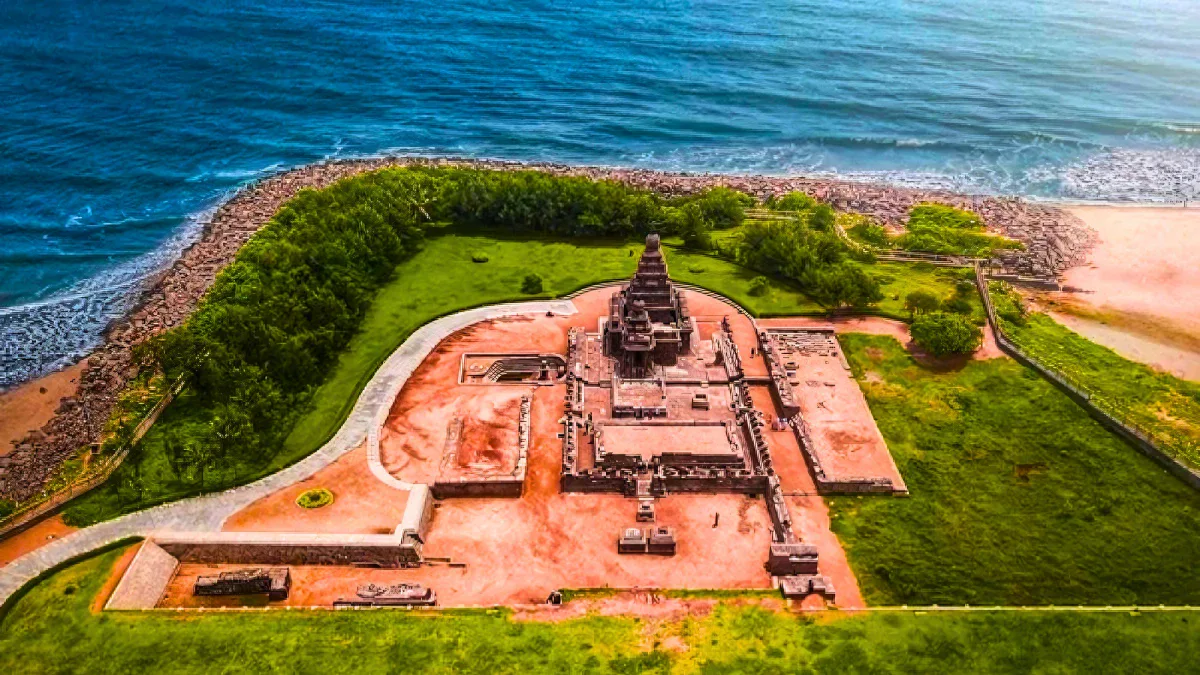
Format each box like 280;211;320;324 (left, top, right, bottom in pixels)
66;229;954;525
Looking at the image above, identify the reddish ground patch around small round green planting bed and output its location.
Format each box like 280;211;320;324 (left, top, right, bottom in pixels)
223;447;408;534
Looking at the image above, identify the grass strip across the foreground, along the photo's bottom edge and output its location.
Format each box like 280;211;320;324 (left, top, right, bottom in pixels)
0;542;1200;675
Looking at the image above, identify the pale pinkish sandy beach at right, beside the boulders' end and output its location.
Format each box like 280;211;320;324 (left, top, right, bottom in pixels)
1044;205;1200;381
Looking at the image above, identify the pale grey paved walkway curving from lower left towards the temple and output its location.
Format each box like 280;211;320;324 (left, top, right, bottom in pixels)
0;300;576;604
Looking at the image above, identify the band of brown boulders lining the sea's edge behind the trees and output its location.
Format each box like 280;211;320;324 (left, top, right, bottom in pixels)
0;157;1096;502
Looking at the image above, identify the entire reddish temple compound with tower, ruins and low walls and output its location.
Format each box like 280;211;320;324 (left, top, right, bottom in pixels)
109;235;906;608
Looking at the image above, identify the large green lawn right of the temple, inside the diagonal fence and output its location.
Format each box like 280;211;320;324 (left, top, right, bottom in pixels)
830;335;1200;605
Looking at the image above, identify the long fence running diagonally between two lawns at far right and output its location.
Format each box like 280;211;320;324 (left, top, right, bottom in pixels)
974;264;1200;490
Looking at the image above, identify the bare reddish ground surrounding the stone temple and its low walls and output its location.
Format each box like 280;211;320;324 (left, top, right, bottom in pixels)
187;281;862;607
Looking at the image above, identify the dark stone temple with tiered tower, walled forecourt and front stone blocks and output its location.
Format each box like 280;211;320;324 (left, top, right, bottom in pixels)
560;234;834;599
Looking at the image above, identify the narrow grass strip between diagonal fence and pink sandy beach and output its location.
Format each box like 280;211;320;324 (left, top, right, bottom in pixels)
991;283;1200;468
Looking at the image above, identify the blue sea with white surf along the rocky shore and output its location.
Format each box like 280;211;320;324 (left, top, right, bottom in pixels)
0;0;1200;387
